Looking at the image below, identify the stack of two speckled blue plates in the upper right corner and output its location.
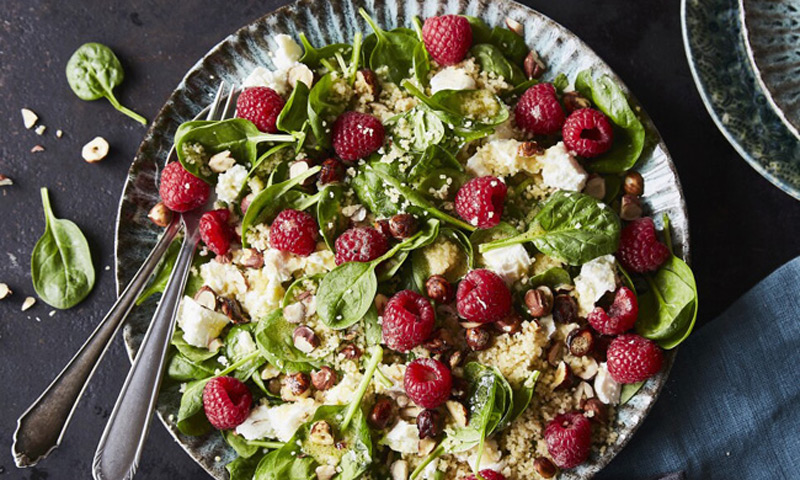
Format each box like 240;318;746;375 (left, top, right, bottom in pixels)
681;0;800;199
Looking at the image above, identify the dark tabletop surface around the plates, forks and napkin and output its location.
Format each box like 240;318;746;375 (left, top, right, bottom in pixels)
0;0;800;480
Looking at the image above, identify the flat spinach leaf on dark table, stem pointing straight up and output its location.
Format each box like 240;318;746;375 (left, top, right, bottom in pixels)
31;188;94;310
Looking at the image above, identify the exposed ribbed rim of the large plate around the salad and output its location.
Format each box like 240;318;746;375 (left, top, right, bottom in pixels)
116;0;689;479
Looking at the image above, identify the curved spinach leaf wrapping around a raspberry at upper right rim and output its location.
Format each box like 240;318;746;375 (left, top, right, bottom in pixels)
575;70;645;173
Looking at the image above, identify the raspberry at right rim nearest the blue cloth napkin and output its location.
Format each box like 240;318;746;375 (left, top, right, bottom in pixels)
606;333;664;383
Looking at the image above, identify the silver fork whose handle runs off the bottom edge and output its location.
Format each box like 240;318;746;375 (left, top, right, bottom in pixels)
92;84;236;480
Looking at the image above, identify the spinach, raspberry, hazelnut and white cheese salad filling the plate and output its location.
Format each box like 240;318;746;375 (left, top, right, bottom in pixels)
142;10;697;480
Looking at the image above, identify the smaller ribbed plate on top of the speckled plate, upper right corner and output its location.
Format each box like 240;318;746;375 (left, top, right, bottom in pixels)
739;0;800;142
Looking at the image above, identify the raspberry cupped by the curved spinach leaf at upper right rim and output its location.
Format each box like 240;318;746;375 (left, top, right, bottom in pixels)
561;108;614;158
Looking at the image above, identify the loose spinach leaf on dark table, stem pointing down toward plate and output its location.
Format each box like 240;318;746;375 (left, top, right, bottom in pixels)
67;43;147;125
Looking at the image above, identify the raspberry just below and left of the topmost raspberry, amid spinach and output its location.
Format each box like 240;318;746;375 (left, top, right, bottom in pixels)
333;112;386;162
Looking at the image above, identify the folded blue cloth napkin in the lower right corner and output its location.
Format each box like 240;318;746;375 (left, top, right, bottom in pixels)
595;257;800;480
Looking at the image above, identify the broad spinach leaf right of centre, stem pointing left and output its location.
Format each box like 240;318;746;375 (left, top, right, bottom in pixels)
480;191;620;265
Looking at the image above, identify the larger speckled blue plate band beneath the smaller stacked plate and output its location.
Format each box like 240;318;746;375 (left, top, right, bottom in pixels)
681;0;800;199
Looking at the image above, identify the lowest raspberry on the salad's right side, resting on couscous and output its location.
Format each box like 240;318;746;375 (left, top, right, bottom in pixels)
544;412;592;468
